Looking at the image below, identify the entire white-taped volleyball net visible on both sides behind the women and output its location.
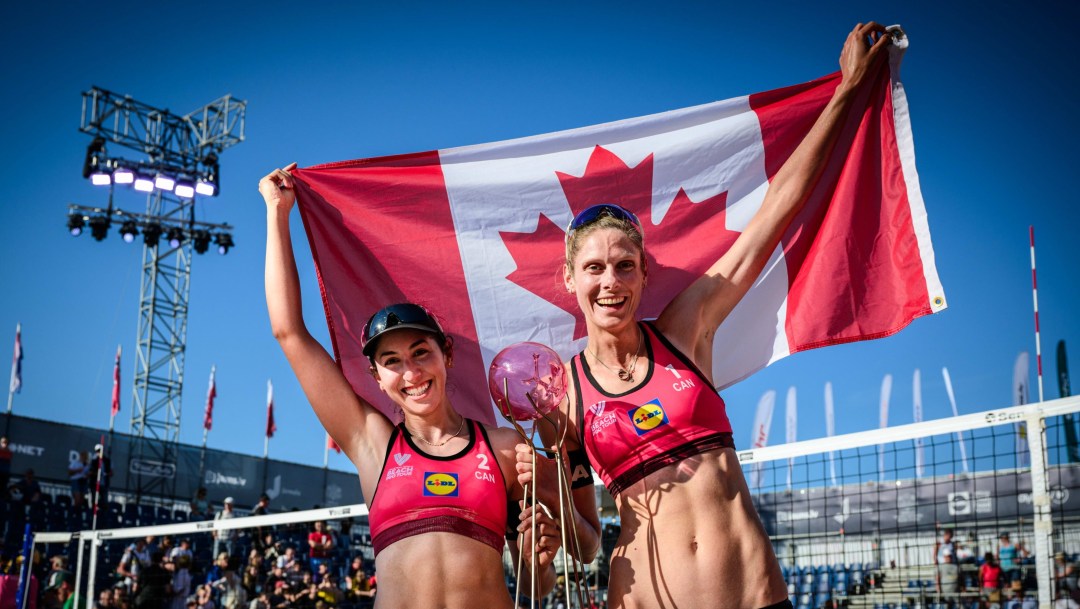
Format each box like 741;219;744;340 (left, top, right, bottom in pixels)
21;397;1080;609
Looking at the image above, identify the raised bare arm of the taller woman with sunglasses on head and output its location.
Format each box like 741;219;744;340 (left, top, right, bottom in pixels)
657;22;890;370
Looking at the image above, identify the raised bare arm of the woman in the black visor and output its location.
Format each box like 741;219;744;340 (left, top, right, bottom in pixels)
259;163;393;481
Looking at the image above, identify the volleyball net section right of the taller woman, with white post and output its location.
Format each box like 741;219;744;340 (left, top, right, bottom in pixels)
739;397;1080;608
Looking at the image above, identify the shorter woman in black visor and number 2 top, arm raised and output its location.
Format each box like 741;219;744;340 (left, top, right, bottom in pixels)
259;163;559;609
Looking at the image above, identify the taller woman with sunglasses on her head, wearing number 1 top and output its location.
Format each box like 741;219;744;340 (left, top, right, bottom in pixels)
518;23;889;609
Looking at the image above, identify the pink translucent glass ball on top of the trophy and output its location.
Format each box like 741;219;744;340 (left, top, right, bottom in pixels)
487;342;566;421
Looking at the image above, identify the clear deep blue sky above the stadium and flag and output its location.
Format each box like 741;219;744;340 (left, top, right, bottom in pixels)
0;0;1080;470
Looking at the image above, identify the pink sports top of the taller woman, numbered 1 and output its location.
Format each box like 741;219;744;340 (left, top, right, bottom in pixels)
571;322;734;495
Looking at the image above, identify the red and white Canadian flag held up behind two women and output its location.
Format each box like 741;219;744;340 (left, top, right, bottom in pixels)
294;33;945;422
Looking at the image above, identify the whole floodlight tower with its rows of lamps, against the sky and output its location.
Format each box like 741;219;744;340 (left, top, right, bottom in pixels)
76;86;247;505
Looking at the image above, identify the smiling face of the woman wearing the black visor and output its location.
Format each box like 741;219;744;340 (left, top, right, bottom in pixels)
373;328;447;415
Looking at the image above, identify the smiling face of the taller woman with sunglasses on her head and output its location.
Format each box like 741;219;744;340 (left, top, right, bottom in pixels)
563;227;645;331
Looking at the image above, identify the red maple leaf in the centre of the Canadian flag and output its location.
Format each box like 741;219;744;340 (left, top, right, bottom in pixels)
499;146;739;339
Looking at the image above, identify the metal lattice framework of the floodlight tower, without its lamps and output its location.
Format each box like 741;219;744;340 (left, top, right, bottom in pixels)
79;87;247;496
